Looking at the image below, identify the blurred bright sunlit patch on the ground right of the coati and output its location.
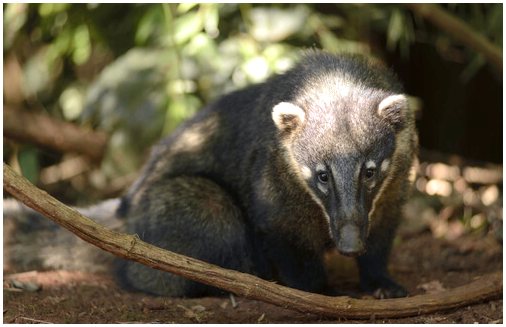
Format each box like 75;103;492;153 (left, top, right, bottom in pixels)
406;158;503;240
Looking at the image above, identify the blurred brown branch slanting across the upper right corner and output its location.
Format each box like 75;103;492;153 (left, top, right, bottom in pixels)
405;3;503;73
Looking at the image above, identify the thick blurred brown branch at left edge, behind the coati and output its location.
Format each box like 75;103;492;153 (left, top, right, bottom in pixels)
4;106;107;162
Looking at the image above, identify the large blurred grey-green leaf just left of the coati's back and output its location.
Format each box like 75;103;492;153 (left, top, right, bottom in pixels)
82;48;169;176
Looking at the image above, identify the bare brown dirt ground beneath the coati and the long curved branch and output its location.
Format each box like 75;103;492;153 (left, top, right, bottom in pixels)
3;223;503;323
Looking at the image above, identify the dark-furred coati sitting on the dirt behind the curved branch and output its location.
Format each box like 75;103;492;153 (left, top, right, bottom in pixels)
3;50;417;298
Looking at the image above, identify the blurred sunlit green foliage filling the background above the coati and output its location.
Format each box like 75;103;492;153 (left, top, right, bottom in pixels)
4;3;502;182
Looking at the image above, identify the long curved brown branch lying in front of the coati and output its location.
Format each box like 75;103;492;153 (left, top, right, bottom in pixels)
3;164;502;319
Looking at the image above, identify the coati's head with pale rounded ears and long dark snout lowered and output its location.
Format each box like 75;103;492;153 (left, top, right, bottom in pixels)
272;55;410;256
